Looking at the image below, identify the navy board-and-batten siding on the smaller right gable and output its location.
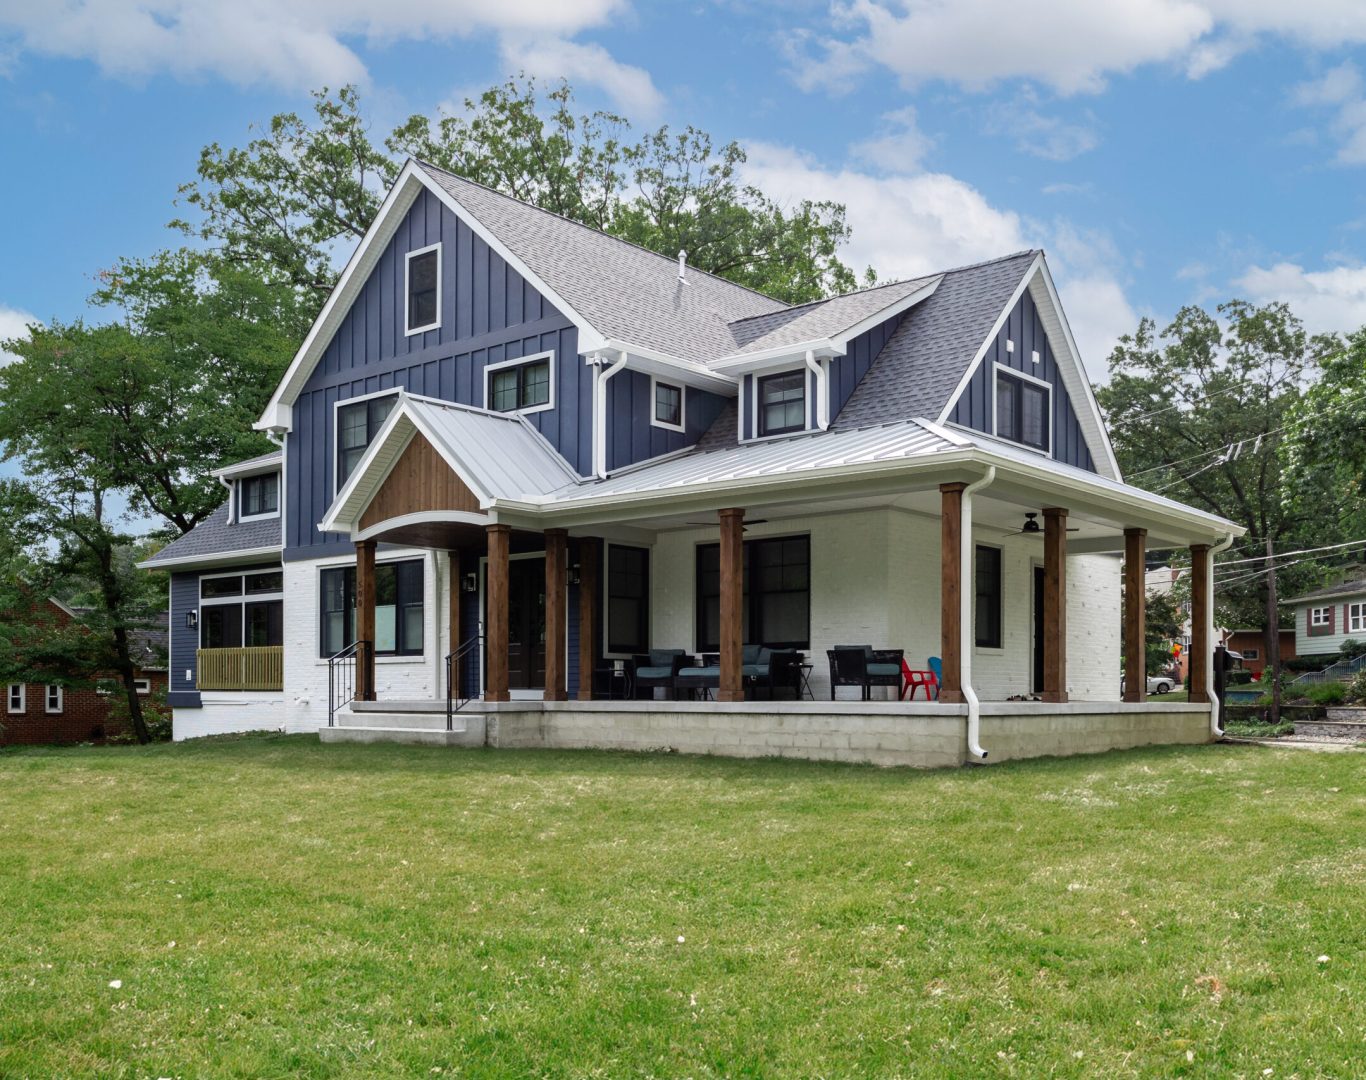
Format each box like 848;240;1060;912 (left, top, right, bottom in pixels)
949;291;1096;472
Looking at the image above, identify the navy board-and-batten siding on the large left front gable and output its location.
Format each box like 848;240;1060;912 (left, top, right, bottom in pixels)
284;191;593;561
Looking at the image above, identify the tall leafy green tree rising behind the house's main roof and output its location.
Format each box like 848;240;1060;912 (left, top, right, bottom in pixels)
173;78;874;310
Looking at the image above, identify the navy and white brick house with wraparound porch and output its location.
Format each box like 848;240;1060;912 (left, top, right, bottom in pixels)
138;161;1240;765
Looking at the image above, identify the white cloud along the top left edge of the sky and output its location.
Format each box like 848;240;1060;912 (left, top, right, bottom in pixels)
0;0;636;96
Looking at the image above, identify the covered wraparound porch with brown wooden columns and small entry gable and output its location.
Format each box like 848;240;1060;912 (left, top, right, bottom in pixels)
325;395;1240;762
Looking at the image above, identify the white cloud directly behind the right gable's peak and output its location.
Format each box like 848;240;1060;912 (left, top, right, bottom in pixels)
746;143;1138;378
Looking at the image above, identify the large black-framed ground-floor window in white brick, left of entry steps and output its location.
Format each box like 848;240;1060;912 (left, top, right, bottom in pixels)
318;558;423;657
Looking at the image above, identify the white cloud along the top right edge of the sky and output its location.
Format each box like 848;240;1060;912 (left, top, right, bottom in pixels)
796;0;1366;94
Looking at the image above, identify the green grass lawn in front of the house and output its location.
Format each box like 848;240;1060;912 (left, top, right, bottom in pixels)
0;736;1366;1077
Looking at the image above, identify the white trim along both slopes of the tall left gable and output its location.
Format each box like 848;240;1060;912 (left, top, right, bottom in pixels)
253;158;604;430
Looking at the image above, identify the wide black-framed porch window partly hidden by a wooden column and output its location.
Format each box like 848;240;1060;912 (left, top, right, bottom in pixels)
697;537;811;653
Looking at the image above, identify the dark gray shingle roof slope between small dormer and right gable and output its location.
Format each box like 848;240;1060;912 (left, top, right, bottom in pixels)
833;251;1038;427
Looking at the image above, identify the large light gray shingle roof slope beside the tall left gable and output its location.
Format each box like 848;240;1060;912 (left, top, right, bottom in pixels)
418;162;787;363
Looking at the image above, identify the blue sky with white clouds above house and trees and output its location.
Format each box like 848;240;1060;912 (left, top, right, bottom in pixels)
0;0;1366;387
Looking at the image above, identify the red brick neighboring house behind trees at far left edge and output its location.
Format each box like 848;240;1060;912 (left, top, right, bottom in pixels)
0;599;167;745
